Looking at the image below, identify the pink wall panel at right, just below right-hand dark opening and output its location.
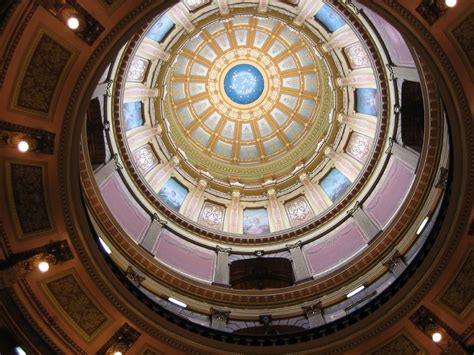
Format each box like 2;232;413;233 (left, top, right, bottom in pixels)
364;156;415;228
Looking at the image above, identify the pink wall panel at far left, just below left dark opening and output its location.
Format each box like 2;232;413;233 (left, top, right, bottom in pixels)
100;173;151;242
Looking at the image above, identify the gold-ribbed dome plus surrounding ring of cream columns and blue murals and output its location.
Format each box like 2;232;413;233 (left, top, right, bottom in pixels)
110;3;388;236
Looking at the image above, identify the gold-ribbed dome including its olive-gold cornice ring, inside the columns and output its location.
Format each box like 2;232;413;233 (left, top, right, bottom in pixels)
156;10;334;183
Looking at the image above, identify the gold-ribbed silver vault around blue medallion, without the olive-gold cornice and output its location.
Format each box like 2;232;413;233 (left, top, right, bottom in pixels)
164;15;327;168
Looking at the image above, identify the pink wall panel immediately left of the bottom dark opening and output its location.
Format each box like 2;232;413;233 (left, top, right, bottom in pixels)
154;229;216;281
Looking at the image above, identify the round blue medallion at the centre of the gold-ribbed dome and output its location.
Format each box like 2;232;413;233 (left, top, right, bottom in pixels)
224;64;265;105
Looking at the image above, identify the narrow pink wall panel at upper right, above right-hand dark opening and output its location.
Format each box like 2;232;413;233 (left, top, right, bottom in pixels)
364;8;415;67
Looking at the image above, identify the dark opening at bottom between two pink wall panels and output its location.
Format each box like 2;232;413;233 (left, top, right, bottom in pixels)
230;258;295;290
